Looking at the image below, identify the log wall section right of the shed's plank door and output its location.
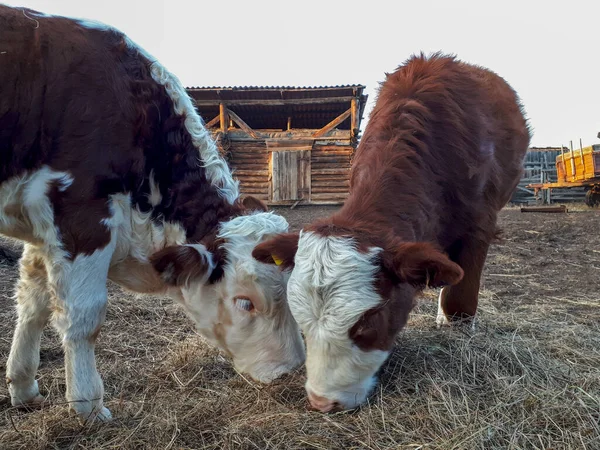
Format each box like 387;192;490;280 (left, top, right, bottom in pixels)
311;143;354;204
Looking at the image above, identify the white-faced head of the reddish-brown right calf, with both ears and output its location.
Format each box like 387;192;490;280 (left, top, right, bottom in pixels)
253;231;463;412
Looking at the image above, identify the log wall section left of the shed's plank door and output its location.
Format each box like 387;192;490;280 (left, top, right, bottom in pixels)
228;141;270;202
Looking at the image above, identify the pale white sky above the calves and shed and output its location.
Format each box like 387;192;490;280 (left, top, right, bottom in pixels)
5;0;600;147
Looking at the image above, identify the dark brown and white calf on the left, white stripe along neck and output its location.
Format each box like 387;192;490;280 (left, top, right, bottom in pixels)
0;5;304;419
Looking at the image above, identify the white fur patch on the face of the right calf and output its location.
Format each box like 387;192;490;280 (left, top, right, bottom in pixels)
288;232;389;408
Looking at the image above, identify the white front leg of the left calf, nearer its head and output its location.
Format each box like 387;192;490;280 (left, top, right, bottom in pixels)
50;240;115;422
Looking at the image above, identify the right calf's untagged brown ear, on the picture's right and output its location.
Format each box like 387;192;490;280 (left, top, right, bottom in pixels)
383;242;464;287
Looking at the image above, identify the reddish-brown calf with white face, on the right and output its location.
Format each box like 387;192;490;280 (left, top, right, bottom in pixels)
253;54;530;411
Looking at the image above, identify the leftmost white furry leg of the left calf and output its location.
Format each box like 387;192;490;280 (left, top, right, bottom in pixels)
6;245;50;406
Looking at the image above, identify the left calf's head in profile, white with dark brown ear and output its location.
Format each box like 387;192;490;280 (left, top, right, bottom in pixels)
151;200;305;383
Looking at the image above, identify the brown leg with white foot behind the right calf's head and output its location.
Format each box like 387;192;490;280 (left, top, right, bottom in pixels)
436;238;490;327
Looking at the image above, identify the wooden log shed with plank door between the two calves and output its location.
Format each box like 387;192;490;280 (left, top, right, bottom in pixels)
188;85;367;205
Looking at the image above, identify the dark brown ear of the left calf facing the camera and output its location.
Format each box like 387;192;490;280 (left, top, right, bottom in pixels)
150;244;215;287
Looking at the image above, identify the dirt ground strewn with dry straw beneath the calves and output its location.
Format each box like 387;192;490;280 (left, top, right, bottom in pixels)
0;207;600;449
